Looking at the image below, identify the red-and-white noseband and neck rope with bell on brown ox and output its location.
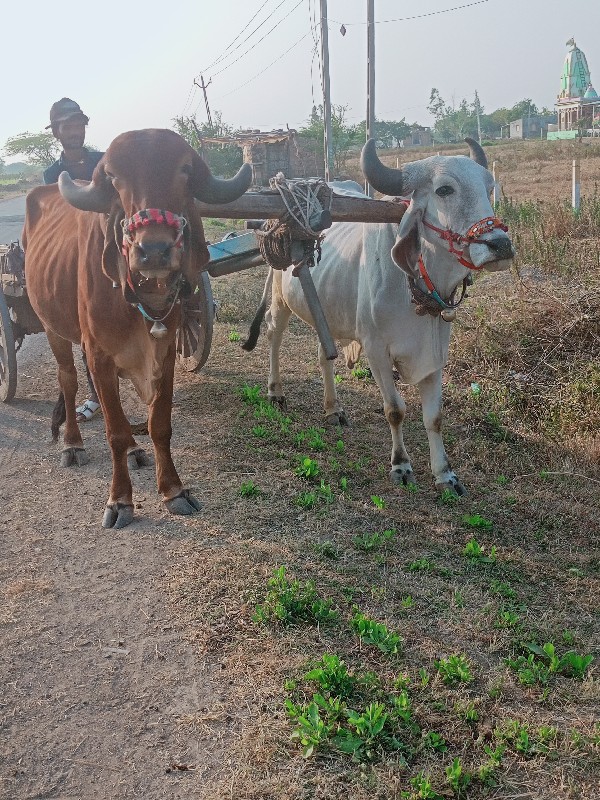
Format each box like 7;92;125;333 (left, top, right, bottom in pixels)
121;208;188;339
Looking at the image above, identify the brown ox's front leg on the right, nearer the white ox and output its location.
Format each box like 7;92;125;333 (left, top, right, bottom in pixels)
148;345;201;515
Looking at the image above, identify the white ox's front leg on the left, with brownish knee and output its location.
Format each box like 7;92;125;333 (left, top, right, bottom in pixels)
365;342;415;486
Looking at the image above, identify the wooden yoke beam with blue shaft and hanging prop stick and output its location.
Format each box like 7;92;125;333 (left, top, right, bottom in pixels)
202;186;406;361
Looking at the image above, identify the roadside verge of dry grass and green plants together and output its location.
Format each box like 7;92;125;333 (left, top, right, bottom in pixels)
162;155;600;800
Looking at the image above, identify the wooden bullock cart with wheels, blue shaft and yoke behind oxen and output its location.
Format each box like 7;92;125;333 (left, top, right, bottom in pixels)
0;179;404;402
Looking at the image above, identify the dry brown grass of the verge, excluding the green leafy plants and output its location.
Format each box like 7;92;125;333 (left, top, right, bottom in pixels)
159;143;600;800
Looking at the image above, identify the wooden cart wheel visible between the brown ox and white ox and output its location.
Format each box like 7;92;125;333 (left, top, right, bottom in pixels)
175;272;215;372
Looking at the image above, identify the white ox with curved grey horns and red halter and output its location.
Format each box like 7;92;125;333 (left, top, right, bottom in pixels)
244;139;514;494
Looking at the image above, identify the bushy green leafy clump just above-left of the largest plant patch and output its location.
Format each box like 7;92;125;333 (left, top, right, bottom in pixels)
253;566;338;626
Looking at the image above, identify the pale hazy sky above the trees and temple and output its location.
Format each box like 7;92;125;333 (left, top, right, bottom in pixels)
0;0;600;161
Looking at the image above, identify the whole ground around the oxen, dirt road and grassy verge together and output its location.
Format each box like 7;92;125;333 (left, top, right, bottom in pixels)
0;142;600;800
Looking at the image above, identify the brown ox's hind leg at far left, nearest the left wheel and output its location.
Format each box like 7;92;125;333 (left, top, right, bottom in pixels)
47;331;88;467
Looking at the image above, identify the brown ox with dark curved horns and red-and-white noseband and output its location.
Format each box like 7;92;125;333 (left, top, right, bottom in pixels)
23;129;251;528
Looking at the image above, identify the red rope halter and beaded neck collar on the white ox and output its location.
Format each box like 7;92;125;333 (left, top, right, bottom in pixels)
401;200;508;322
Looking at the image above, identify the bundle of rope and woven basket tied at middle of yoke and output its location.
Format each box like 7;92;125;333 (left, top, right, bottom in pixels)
256;172;333;275
